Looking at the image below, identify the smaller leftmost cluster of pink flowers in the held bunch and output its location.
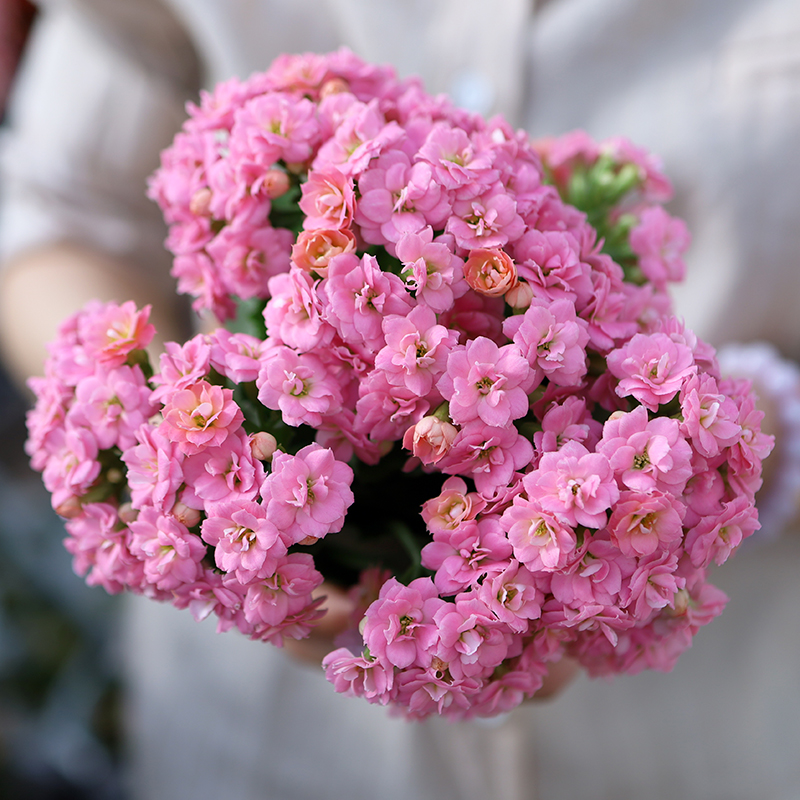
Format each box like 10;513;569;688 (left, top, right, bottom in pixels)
28;303;353;644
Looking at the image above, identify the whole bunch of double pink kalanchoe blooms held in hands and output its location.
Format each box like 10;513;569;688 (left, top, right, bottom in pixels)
28;51;771;718
